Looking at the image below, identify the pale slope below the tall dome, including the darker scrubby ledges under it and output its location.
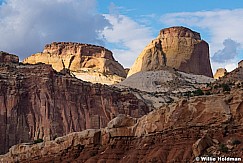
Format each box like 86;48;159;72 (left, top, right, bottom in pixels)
114;67;215;108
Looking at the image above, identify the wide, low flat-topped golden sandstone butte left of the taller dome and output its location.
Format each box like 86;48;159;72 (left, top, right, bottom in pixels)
23;42;127;84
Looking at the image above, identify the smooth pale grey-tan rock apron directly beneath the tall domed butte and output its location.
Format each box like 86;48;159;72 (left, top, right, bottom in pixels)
118;68;215;93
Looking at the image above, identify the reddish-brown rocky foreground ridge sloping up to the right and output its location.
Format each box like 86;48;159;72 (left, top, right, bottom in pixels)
0;85;243;163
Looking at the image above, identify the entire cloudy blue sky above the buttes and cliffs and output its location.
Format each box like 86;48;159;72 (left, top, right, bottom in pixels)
0;0;243;71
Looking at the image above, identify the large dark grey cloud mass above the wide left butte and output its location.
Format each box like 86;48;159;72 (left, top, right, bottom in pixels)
0;0;110;59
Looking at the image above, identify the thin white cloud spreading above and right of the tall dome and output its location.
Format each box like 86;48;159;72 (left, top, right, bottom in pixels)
161;9;243;71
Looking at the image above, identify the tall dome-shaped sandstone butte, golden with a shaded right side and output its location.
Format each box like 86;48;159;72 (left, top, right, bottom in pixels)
128;27;213;77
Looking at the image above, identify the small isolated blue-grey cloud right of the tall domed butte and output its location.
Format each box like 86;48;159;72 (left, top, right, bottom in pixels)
212;39;240;63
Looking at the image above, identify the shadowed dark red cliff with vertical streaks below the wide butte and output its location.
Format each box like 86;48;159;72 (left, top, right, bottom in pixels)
0;53;149;154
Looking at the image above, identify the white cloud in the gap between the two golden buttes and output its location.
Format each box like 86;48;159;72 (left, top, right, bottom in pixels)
103;14;153;67
